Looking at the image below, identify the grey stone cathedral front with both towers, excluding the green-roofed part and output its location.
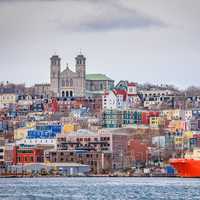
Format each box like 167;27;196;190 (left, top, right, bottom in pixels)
50;54;86;97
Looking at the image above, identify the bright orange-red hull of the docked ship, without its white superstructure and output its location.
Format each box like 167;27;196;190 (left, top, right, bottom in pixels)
170;158;200;178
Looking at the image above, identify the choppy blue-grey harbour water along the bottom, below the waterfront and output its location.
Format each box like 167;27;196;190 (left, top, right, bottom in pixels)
0;177;200;200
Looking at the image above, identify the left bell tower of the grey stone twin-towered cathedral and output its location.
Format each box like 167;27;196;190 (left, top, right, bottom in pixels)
50;55;61;96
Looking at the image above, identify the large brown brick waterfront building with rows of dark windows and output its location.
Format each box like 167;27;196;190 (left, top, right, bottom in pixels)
45;130;129;173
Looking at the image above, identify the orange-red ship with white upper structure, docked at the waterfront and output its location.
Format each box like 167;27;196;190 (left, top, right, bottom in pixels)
169;149;200;178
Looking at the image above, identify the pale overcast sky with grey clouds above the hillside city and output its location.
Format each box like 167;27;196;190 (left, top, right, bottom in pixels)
0;0;200;88
